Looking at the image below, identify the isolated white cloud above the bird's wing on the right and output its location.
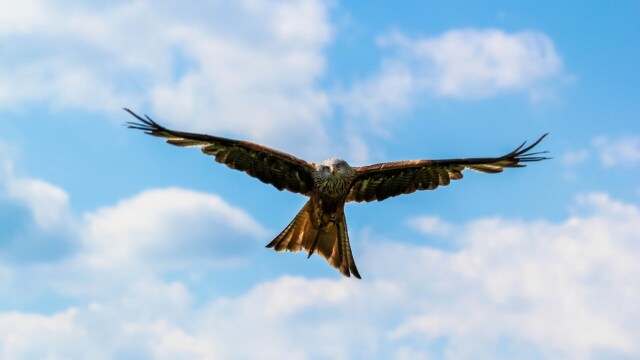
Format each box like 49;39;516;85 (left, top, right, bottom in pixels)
416;29;560;98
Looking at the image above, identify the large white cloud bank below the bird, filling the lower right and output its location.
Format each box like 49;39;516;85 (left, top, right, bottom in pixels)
156;194;640;358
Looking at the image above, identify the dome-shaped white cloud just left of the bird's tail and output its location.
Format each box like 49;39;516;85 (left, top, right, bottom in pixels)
82;188;267;267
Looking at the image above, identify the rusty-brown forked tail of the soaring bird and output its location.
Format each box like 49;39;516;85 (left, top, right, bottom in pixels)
267;201;360;279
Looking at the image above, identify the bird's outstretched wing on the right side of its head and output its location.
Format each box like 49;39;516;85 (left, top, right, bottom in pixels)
347;134;548;202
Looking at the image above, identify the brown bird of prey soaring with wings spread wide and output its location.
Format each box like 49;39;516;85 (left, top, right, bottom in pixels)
124;108;548;279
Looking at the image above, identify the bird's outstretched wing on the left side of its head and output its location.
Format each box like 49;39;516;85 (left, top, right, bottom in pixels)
124;108;313;195
